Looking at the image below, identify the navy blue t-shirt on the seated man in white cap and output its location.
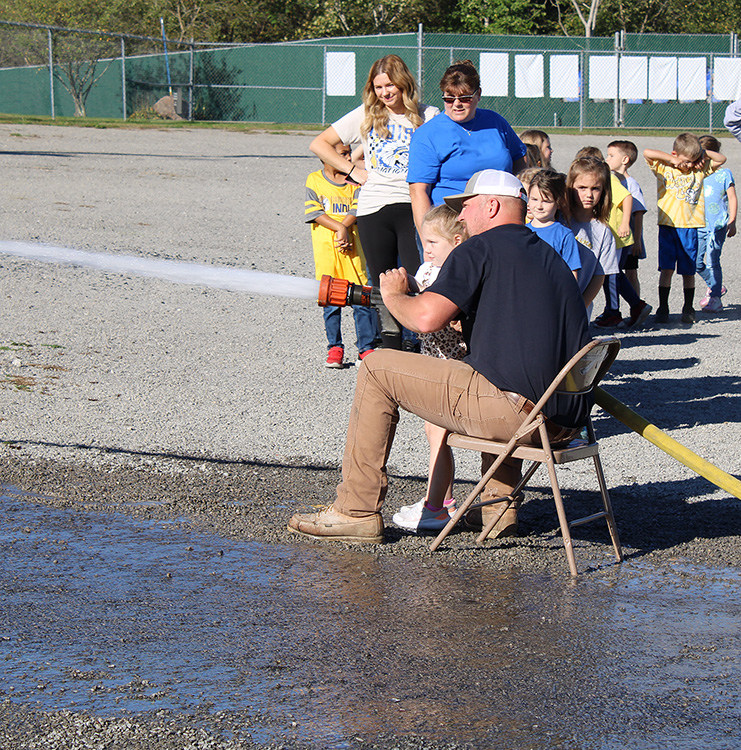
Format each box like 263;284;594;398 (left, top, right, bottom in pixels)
427;224;591;427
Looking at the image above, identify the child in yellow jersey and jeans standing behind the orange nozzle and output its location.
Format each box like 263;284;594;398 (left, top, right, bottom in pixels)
304;143;376;369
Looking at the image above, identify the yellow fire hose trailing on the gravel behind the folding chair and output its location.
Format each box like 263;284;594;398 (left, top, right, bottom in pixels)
594;386;741;499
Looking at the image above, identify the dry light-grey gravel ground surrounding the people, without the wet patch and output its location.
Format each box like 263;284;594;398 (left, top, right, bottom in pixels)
0;125;741;748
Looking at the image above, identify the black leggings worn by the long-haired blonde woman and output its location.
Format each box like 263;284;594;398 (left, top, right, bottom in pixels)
357;203;420;349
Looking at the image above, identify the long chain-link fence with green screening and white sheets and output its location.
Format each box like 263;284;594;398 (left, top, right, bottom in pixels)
0;21;741;131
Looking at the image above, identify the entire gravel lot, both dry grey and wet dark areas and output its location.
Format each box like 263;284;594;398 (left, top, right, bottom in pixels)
0;125;741;748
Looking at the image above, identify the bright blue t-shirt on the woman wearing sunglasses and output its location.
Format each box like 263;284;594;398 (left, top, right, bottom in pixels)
407;109;527;206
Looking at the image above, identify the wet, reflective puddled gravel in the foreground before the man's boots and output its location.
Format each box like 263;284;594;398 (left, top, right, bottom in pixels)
0;489;741;750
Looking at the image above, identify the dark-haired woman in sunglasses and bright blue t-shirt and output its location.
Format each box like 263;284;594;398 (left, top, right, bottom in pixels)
407;60;526;231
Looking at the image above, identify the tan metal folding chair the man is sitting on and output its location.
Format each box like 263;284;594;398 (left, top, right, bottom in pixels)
430;336;623;576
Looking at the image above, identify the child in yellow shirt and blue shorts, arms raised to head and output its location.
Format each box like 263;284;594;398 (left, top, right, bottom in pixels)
643;133;726;325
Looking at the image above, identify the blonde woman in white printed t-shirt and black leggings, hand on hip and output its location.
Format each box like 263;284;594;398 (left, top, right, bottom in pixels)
310;55;440;345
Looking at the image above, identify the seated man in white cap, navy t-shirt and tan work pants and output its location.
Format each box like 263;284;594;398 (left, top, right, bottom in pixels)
288;169;591;543
